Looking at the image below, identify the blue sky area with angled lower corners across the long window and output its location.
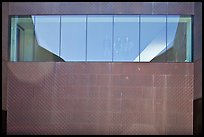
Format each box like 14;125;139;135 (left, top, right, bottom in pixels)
32;15;179;62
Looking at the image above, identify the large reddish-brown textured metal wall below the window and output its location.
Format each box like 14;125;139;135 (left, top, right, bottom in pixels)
7;62;193;135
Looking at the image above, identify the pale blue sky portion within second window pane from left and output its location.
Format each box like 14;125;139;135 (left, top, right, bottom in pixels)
34;15;60;56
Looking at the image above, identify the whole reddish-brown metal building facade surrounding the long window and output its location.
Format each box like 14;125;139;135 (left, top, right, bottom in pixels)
2;2;202;134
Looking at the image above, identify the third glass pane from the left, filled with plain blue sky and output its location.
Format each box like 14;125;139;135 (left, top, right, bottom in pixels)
61;16;86;61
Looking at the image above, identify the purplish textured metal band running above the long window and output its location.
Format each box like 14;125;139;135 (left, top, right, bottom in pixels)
9;2;194;15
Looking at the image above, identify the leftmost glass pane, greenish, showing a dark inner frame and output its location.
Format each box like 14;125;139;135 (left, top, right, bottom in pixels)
10;16;35;61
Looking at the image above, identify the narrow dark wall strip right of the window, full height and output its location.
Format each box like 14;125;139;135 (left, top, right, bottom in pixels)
193;2;203;135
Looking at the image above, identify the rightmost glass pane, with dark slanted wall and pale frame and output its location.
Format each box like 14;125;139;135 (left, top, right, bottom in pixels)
167;15;192;62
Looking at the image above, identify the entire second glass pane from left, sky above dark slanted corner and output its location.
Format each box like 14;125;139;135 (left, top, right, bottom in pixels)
34;15;63;61
